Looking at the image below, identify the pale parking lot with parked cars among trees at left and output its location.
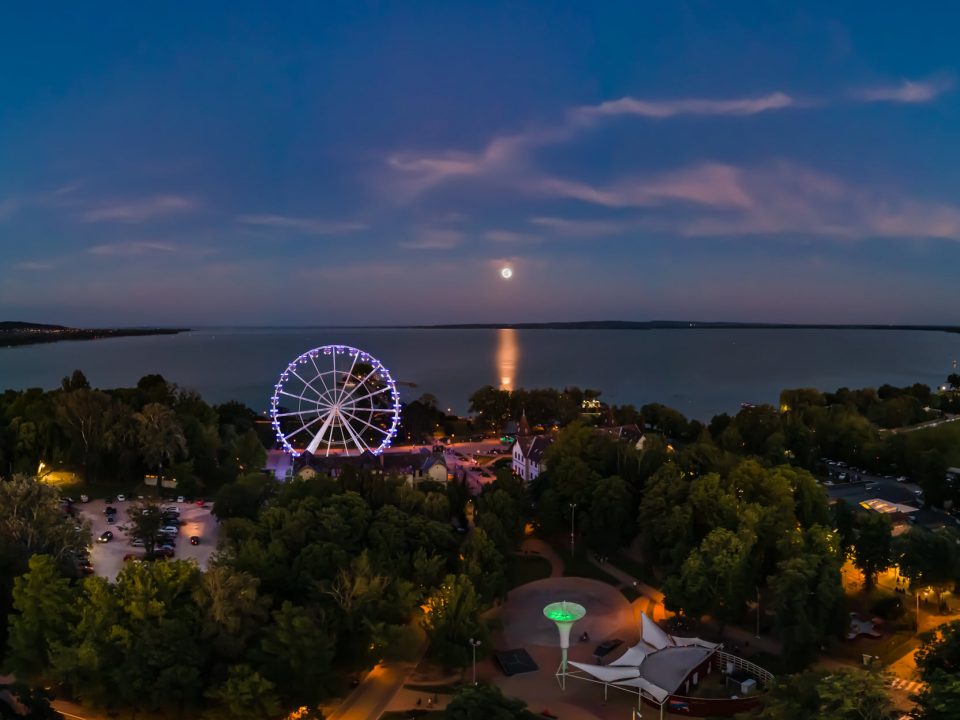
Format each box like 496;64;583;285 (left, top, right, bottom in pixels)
75;500;219;582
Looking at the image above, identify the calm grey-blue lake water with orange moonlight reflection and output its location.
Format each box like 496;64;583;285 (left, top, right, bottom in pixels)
0;328;960;420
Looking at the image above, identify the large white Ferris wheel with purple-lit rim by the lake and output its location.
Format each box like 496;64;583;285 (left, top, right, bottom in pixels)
270;345;400;456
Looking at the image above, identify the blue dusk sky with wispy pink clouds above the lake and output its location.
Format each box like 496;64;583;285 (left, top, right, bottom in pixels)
0;1;960;325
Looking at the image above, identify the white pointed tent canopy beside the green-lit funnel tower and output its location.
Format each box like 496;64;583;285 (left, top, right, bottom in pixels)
567;613;720;715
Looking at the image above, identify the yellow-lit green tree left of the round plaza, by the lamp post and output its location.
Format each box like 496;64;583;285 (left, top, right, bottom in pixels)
423;575;486;667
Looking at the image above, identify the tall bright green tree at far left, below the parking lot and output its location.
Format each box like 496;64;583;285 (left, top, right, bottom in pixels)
9;555;74;680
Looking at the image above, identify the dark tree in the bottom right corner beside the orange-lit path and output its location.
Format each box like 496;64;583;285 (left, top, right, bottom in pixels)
915;620;960;720
